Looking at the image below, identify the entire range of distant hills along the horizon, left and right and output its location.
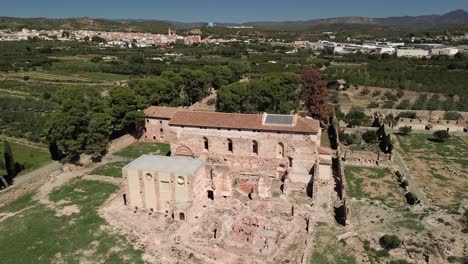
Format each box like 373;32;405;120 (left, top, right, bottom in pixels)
0;10;468;34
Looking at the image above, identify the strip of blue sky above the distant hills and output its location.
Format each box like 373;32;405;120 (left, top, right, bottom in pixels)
0;0;468;22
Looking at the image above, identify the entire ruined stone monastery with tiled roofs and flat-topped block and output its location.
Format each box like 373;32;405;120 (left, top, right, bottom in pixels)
123;106;332;221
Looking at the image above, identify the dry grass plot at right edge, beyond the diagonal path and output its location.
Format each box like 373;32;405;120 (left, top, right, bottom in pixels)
396;133;468;207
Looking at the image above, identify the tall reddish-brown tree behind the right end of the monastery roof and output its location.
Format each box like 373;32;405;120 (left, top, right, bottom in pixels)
301;67;330;121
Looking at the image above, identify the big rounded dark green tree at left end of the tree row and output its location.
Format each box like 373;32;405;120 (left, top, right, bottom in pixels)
46;87;112;162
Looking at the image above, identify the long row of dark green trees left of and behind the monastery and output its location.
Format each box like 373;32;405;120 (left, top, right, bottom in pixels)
46;64;252;162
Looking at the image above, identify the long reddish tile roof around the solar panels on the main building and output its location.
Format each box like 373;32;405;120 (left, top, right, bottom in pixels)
169;111;320;133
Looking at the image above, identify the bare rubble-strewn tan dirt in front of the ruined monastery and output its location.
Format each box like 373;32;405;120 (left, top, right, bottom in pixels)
99;182;332;263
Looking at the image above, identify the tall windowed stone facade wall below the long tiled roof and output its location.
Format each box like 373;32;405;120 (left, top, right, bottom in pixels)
171;126;319;198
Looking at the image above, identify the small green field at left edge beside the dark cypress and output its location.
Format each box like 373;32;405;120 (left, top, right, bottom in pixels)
0;141;52;175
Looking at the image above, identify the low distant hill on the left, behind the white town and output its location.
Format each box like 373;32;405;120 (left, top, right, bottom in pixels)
0;17;175;33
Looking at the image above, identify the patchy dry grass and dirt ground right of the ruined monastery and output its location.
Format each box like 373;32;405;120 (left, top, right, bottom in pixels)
312;133;468;264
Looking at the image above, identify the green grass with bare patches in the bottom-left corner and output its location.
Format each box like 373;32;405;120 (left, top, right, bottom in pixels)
0;179;143;264
